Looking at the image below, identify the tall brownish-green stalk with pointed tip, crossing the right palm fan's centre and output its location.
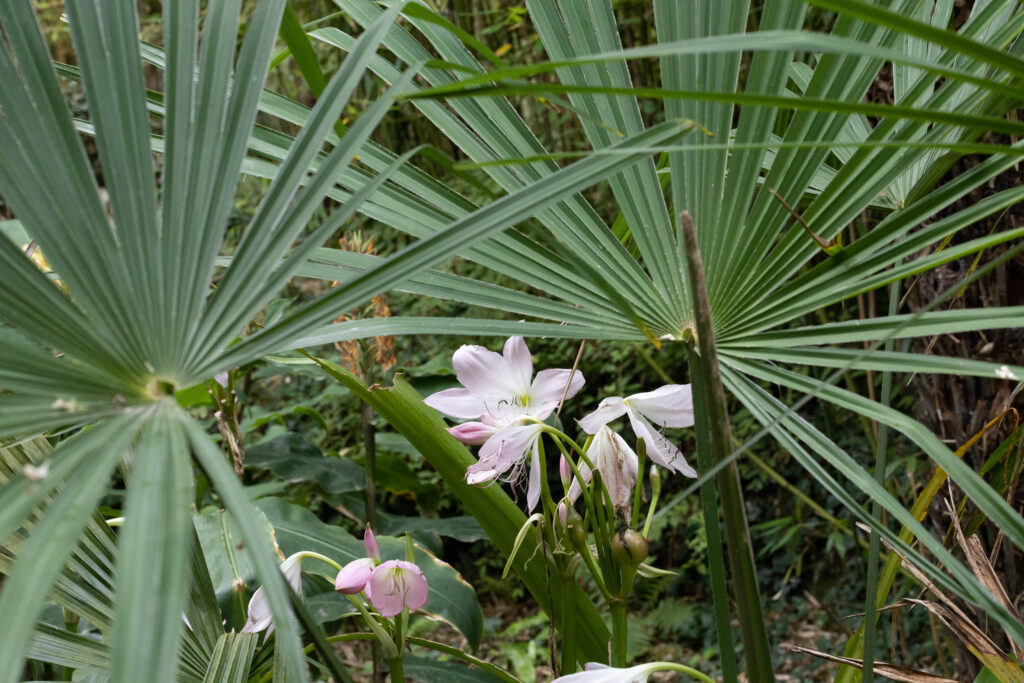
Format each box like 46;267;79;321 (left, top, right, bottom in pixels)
680;212;775;683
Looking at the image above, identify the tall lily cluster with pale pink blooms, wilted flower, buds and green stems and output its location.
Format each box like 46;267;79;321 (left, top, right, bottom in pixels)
425;337;696;675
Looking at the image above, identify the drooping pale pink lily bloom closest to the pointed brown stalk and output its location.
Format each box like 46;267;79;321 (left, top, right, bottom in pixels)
579;384;697;477
